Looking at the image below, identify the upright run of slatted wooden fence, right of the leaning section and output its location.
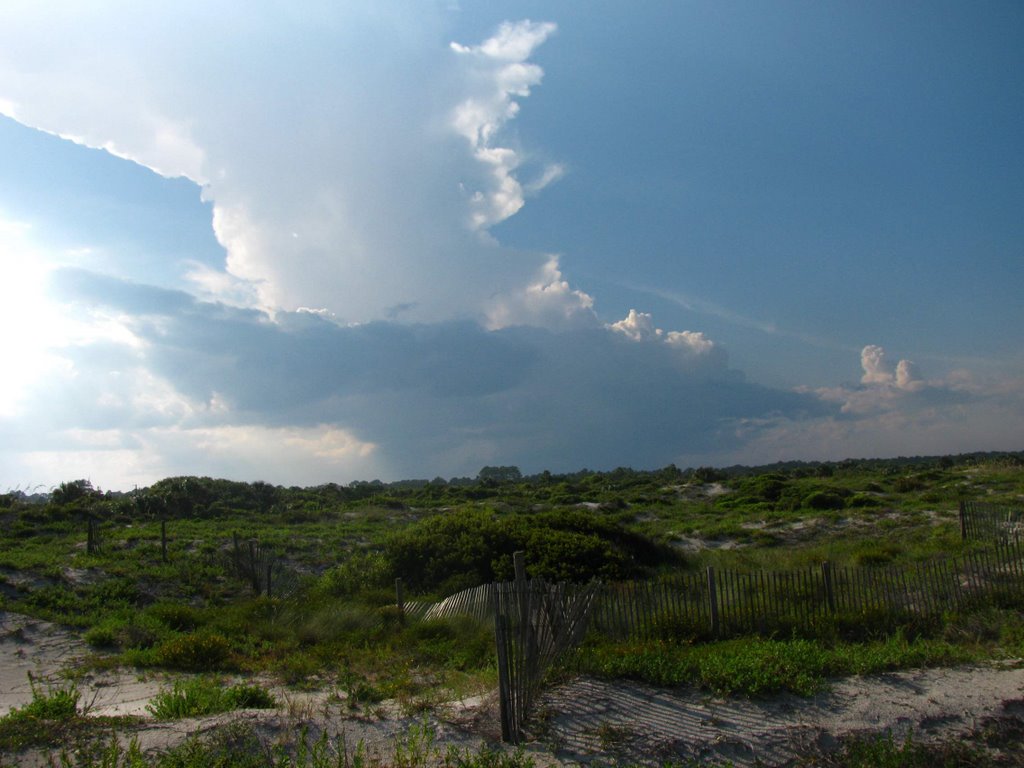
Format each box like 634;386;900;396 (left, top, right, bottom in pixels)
591;542;1024;640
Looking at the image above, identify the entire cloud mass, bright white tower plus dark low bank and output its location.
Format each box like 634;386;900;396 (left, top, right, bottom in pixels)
0;7;1024;486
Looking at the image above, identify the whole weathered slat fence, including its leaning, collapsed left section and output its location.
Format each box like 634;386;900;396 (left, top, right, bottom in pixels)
397;541;1024;742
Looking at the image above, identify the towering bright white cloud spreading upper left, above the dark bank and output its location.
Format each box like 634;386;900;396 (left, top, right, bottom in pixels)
0;6;577;322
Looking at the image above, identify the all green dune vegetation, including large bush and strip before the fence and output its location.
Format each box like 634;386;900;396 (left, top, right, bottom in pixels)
0;454;1024;766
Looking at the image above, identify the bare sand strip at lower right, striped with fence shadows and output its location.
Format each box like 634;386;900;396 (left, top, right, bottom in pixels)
539;665;1024;766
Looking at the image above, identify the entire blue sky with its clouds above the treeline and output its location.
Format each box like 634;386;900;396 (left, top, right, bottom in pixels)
0;0;1024;492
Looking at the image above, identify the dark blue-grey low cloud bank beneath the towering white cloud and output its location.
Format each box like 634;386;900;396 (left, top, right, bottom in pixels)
2;268;827;487
